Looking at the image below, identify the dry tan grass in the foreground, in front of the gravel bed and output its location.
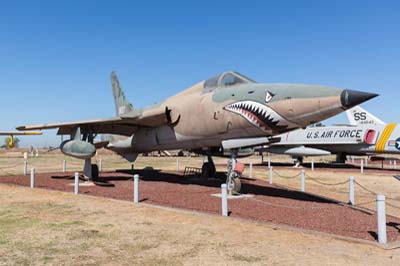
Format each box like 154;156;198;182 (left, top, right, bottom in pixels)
0;185;400;265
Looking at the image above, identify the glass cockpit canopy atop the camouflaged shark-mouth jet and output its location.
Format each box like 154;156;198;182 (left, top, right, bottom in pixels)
204;71;255;89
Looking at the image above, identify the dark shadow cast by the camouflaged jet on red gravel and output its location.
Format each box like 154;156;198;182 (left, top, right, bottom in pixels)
117;170;339;204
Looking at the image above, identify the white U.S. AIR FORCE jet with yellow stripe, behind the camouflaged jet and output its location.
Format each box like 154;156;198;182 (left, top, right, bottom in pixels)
265;106;400;163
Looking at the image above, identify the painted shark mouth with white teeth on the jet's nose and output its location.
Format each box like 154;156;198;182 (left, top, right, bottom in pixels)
224;101;298;131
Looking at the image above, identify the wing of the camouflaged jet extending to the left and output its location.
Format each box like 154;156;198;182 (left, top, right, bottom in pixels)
17;111;168;136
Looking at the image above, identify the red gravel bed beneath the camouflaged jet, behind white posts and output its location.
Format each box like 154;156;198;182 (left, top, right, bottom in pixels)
0;170;400;242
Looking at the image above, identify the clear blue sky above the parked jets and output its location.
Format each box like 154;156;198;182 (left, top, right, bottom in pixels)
0;0;400;145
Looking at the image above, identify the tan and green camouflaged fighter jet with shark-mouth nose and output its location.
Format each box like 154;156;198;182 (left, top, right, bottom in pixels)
17;72;377;190
